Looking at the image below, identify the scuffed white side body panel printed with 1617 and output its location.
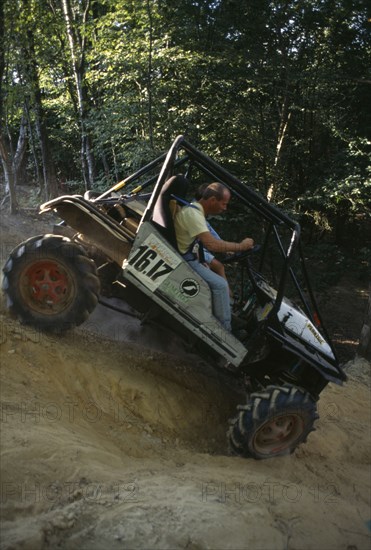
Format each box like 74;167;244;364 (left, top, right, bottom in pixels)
122;222;247;367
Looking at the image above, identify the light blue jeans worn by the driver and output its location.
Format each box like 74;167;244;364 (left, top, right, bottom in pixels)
188;260;231;331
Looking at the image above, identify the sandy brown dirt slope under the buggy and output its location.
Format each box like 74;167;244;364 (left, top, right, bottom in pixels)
0;209;371;550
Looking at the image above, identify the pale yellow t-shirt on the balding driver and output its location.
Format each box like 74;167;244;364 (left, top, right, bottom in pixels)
174;202;209;254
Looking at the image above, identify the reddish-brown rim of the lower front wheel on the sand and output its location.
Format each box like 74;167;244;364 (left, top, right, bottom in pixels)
254;414;304;455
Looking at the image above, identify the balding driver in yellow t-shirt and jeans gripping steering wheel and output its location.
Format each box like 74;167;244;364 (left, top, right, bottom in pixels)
174;183;254;331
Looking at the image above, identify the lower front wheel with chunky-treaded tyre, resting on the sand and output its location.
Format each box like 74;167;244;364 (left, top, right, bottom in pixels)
228;384;318;459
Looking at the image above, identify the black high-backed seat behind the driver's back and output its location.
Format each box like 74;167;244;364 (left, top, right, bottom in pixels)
152;174;189;249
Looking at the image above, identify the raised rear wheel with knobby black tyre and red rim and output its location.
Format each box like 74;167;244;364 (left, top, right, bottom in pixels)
3;235;100;330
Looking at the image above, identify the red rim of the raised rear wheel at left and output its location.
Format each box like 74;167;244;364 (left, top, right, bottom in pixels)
21;259;74;315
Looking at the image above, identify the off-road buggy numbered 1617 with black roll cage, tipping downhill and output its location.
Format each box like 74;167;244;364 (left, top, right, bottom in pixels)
3;136;346;459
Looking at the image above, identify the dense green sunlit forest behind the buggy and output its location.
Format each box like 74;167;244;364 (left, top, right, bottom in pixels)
0;0;371;292
